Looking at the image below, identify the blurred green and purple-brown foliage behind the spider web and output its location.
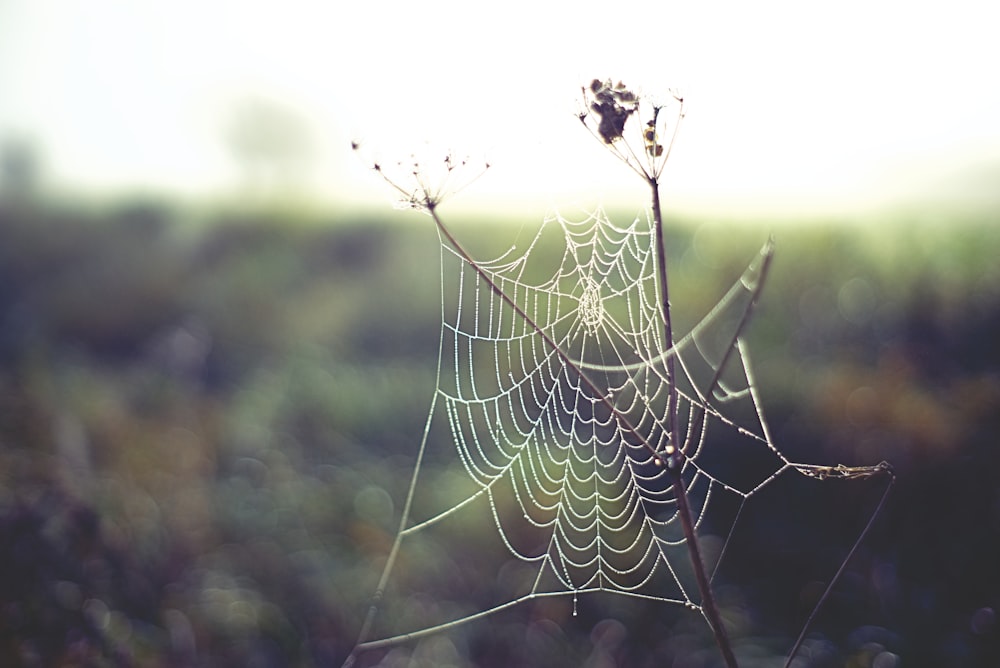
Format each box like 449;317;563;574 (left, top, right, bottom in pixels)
0;200;1000;668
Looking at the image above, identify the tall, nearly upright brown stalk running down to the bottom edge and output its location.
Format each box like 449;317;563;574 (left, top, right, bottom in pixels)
648;176;738;668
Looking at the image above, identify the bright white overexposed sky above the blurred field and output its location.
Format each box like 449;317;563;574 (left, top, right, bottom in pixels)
0;0;1000;215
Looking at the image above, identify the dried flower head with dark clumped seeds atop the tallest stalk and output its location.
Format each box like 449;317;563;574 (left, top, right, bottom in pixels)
579;79;684;181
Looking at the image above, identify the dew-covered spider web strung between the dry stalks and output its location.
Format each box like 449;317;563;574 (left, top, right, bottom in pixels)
352;210;884;647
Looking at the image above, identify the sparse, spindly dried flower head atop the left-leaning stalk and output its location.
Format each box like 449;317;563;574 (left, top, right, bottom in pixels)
351;141;490;213
